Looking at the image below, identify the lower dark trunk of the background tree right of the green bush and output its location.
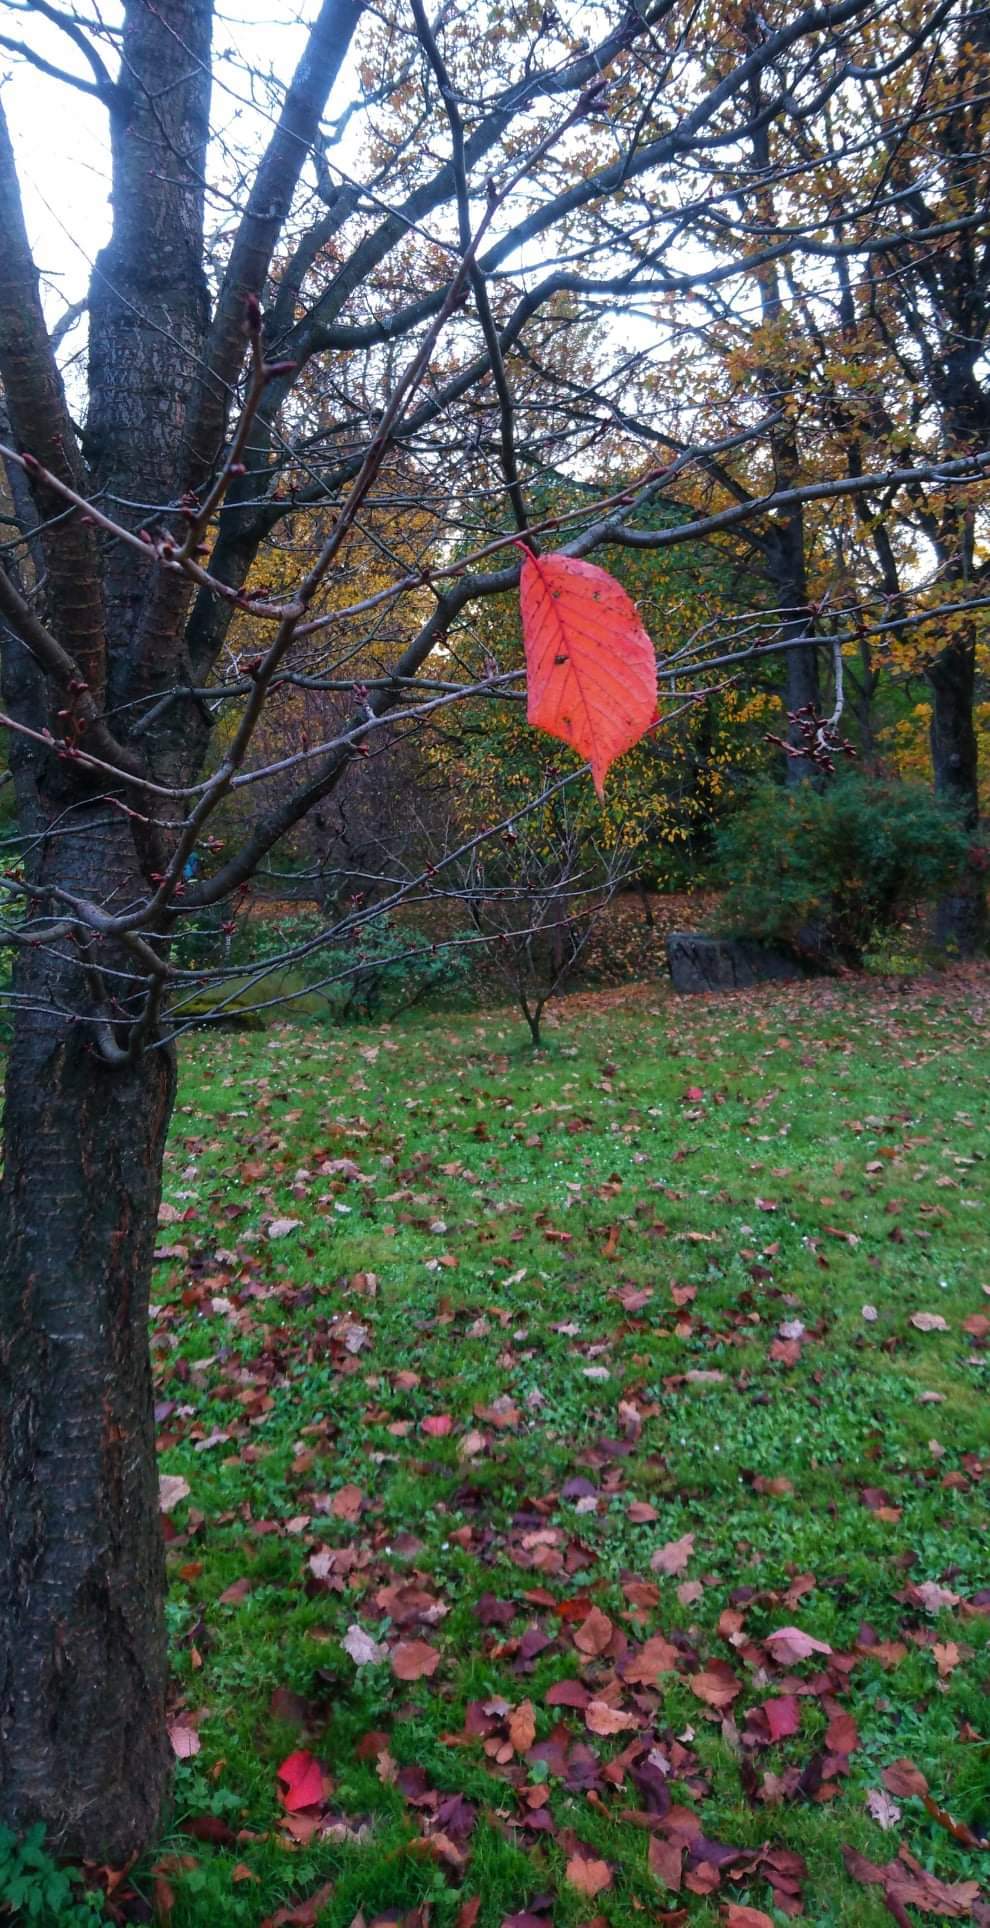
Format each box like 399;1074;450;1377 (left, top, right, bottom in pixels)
928;638;986;956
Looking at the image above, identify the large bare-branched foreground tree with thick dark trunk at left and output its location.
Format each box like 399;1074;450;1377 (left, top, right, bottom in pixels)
0;0;986;1864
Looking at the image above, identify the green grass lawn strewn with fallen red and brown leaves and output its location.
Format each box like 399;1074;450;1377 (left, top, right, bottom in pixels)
139;976;990;1928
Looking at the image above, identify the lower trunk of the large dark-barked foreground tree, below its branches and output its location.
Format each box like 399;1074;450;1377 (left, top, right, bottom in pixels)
0;840;174;1866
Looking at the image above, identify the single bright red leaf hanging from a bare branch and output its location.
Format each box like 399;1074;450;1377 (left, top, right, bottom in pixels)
519;555;656;796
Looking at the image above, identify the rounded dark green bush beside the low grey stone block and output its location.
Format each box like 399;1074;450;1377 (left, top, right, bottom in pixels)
716;775;969;966
